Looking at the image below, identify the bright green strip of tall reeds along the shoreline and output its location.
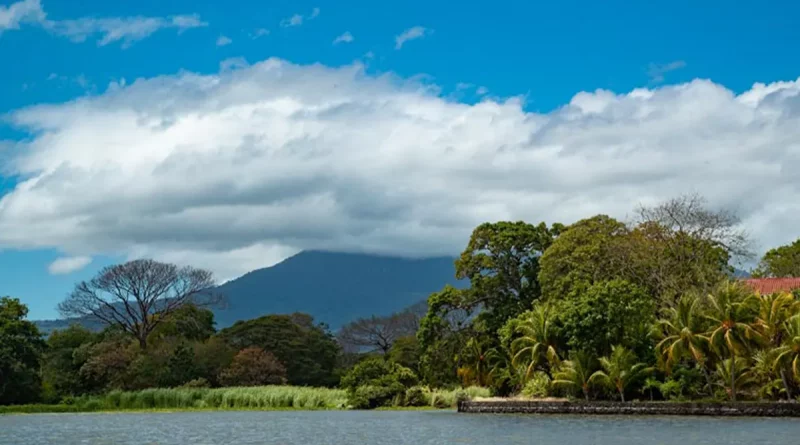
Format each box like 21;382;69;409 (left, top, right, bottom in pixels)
0;386;489;414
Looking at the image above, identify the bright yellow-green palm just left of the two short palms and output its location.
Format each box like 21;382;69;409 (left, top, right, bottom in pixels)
511;305;559;381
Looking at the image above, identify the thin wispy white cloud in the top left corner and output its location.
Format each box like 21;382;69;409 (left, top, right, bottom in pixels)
0;0;208;48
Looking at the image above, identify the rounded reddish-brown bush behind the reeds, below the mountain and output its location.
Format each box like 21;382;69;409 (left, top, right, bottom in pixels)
219;347;286;386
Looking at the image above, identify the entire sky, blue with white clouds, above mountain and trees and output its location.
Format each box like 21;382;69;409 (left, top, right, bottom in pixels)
0;0;800;319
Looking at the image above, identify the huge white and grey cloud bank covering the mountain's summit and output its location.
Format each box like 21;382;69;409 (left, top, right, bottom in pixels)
0;59;800;278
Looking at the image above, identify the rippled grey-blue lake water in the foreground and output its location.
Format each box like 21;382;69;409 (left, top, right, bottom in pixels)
0;411;800;445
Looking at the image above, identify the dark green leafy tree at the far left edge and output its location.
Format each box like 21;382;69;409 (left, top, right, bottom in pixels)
0;297;46;405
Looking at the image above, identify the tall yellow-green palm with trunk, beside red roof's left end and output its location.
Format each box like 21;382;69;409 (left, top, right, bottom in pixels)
704;282;759;401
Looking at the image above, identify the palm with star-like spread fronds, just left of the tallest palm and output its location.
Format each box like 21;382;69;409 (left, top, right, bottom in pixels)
656;294;708;374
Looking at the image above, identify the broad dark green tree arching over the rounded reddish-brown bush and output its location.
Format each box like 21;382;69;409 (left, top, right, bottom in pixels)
219;314;339;386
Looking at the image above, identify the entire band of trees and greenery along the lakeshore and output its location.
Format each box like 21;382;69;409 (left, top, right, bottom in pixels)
0;195;800;412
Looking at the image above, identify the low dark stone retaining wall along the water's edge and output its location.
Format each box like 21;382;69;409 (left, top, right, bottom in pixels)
458;400;800;417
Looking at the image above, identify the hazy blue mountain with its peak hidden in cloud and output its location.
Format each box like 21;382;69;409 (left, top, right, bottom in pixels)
214;251;466;329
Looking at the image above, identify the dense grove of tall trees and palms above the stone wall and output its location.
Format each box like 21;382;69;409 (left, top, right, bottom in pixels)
417;196;800;400
